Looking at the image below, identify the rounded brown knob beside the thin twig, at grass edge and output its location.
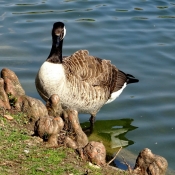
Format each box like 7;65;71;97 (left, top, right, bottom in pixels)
83;141;106;166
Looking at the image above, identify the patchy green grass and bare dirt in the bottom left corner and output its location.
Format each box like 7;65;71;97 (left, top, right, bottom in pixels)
0;113;129;175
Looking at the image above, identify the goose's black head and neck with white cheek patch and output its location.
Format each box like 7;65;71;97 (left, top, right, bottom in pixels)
46;22;66;64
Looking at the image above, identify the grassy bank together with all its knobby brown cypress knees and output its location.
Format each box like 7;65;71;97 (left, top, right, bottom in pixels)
0;68;168;175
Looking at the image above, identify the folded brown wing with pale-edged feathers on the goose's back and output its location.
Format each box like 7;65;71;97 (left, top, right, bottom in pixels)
63;50;127;93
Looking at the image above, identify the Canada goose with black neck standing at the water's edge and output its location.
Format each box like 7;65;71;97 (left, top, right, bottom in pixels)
35;22;139;124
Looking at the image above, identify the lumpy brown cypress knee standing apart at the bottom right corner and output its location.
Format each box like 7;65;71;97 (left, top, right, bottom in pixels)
133;148;168;175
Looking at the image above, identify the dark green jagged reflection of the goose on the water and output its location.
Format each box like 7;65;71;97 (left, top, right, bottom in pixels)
81;119;137;155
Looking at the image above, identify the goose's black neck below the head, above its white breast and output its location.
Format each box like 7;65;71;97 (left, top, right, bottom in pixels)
47;37;63;64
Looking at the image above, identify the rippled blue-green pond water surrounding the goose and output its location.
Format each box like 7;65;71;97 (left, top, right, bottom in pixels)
0;0;175;174
